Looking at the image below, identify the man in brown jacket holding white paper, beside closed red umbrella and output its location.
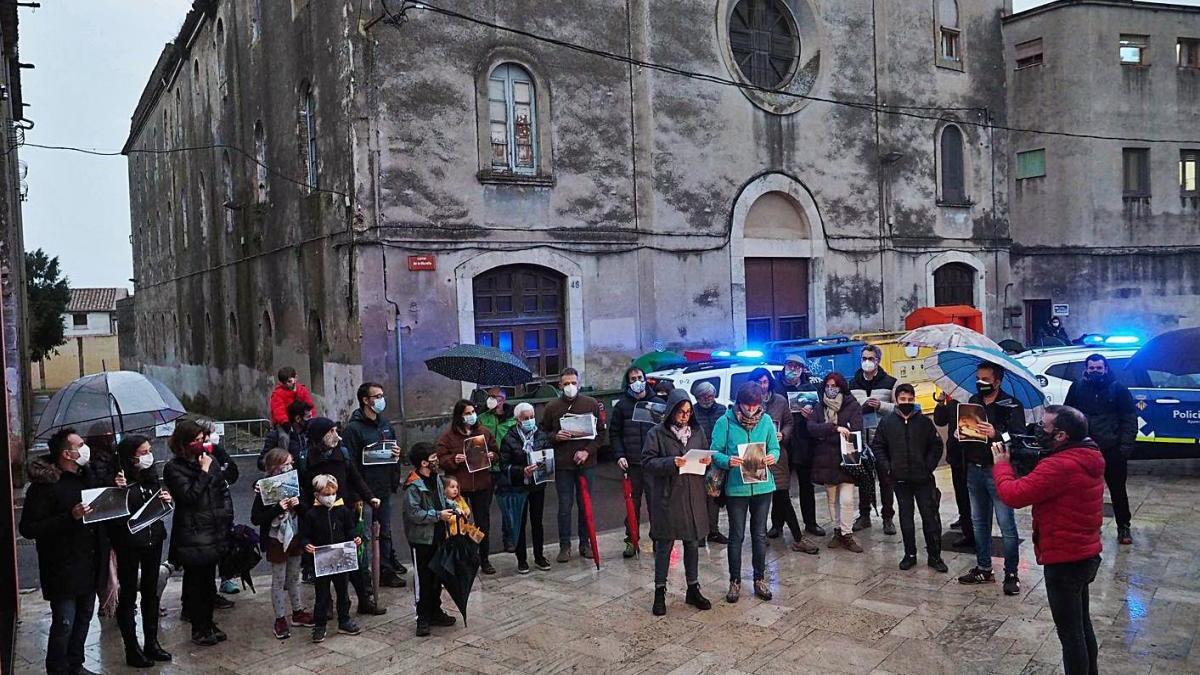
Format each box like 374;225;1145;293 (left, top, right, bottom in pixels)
539;368;607;562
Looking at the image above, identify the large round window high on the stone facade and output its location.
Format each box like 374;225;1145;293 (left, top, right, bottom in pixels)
730;0;800;89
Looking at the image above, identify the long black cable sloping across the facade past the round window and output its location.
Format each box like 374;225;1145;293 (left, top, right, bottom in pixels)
379;0;1200;145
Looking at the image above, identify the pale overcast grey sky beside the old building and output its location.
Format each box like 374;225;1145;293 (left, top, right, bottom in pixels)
19;0;1200;287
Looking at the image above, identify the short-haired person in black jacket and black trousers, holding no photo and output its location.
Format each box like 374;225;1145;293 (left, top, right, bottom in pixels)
871;383;948;573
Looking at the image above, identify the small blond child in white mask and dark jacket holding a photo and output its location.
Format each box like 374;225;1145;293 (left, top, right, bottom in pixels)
300;473;362;643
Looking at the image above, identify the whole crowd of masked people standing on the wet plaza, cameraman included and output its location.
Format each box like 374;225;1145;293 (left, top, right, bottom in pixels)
20;346;1135;674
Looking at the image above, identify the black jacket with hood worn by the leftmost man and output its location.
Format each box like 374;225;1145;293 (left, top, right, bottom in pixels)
19;454;108;602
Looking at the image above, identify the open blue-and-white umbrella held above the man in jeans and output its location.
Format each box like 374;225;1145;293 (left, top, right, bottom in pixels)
925;347;1046;410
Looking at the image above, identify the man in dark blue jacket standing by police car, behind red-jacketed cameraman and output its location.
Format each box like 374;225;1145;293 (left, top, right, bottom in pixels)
1063;354;1138;545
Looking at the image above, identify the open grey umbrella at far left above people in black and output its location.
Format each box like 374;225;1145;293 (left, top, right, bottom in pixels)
35;370;187;440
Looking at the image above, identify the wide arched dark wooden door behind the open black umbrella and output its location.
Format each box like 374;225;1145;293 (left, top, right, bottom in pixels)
474;265;566;394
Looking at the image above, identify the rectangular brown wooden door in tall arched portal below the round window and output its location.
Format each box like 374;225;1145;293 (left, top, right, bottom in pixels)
745;258;809;345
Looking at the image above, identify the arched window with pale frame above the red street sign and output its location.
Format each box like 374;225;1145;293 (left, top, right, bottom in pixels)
487;64;538;174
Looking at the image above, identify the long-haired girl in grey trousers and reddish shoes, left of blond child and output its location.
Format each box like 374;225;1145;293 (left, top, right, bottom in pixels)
250;448;313;640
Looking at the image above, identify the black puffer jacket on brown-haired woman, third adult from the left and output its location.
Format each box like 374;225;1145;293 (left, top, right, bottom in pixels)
162;456;233;566
